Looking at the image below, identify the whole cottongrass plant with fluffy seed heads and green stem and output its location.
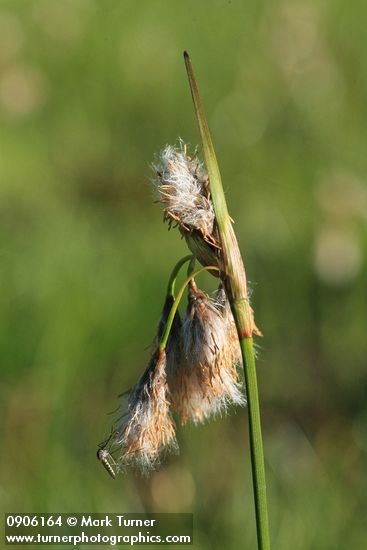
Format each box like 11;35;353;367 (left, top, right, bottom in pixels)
97;53;270;550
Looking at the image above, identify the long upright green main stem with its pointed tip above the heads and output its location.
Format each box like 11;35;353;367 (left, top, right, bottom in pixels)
184;52;270;550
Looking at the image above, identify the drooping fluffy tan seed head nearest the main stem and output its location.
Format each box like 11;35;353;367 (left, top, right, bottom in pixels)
169;283;245;423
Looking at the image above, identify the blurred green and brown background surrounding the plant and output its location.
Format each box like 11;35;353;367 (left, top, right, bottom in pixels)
0;0;367;550
